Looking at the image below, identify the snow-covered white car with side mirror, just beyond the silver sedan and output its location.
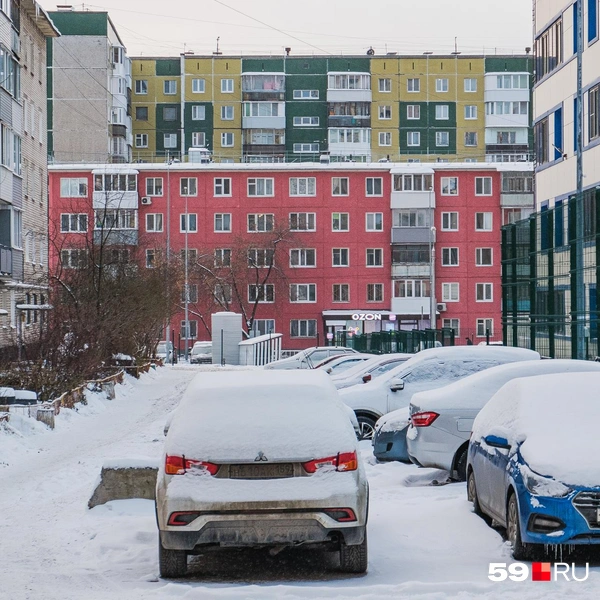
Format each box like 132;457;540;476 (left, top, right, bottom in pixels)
340;346;540;439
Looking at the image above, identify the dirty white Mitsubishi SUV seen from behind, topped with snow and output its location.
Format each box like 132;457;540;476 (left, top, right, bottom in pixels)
156;370;368;577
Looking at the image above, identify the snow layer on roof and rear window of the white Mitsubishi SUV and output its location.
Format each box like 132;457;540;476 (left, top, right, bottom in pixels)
165;370;357;462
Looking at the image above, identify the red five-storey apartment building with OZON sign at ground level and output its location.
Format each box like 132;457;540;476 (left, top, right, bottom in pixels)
49;163;533;350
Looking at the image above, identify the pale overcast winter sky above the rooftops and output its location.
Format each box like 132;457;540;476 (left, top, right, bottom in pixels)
48;0;532;56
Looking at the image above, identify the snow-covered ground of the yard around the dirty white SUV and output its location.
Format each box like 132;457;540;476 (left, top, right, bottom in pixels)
0;365;600;600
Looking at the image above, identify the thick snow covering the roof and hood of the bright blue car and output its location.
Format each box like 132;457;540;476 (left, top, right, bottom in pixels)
472;373;600;487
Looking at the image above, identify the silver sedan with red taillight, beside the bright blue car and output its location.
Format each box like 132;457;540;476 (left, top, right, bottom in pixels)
404;360;600;481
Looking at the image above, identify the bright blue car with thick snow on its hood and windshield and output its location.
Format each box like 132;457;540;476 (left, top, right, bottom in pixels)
467;373;600;560
